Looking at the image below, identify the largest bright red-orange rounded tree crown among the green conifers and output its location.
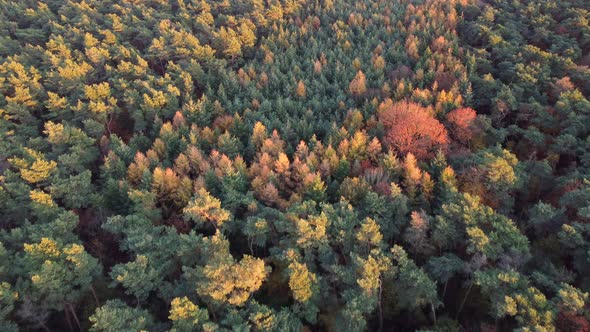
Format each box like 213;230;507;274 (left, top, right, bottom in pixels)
379;101;449;159
